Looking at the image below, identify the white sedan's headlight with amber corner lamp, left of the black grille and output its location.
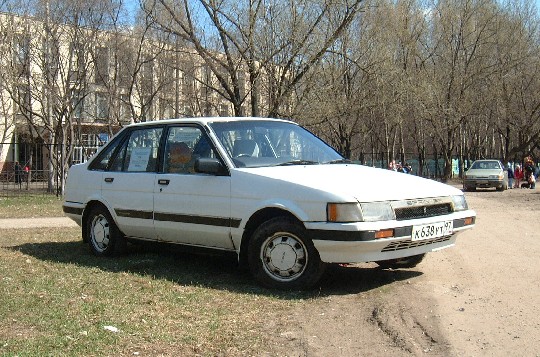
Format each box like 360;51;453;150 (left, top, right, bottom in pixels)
326;202;395;222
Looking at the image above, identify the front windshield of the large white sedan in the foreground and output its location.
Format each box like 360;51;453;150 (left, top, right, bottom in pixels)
209;120;344;167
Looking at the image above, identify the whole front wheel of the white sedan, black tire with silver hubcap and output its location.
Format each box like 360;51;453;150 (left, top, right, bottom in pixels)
248;217;326;290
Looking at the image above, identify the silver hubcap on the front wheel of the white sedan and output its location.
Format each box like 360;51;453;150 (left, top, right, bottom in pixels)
261;233;308;281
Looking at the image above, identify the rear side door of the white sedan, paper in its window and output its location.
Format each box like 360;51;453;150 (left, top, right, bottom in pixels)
101;127;163;239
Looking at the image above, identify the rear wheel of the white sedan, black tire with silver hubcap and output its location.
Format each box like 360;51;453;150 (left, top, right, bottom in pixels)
86;206;127;256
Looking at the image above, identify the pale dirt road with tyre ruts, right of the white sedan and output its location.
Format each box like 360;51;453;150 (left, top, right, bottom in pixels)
276;189;540;356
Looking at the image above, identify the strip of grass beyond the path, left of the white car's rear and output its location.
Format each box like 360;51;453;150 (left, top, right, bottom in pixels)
0;195;63;218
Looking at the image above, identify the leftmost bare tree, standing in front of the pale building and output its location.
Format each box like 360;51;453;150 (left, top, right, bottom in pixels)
0;1;117;194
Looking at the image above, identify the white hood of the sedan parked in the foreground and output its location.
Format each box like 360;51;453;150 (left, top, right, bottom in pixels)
234;164;462;202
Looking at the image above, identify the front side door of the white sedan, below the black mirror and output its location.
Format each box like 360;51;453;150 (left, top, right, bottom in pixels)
154;125;235;249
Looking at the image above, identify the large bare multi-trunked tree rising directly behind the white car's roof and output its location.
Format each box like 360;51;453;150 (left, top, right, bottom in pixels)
145;0;361;116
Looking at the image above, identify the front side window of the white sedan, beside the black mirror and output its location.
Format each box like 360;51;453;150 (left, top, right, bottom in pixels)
163;126;216;174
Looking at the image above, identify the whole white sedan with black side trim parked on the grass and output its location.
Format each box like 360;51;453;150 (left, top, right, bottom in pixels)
63;118;476;289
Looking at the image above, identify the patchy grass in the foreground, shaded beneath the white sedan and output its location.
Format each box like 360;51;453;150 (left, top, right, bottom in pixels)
0;228;418;356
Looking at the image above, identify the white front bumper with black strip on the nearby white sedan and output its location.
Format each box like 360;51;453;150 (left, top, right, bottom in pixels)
306;210;476;263
